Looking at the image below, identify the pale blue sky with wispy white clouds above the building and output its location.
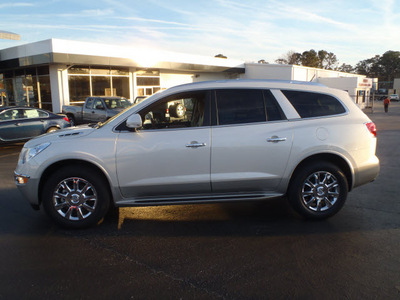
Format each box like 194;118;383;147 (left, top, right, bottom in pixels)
0;0;400;66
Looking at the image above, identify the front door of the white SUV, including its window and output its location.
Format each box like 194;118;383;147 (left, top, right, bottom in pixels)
116;92;211;199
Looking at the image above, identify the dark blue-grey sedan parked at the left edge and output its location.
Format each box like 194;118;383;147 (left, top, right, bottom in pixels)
0;106;70;143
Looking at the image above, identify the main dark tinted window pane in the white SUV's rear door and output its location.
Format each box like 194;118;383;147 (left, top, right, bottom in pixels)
216;89;266;125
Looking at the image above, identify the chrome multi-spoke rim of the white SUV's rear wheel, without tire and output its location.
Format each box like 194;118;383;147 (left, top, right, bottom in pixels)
301;171;340;212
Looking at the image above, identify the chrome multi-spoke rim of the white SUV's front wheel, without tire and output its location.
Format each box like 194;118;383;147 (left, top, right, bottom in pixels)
53;177;98;221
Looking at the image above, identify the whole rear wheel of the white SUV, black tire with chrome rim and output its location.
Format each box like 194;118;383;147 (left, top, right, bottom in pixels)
288;161;348;219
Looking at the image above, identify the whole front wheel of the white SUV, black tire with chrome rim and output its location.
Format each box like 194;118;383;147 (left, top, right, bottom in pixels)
42;165;111;228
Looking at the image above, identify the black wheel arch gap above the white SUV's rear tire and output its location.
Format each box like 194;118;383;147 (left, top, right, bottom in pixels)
289;153;353;191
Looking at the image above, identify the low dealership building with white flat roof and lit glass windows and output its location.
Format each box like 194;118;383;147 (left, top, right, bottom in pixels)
0;39;377;112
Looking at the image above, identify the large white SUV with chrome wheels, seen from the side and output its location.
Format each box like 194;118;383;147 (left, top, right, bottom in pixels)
15;80;379;228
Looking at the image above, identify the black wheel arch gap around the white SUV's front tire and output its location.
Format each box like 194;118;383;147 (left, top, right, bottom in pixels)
38;159;114;205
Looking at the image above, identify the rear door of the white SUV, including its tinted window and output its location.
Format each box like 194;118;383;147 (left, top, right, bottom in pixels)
211;90;293;193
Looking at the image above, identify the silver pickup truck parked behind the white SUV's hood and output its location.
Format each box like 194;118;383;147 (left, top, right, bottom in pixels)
62;96;132;126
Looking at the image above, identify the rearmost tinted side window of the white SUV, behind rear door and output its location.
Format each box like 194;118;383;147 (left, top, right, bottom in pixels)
282;91;346;118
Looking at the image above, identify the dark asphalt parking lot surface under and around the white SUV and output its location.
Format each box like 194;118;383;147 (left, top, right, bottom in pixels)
0;102;400;299
